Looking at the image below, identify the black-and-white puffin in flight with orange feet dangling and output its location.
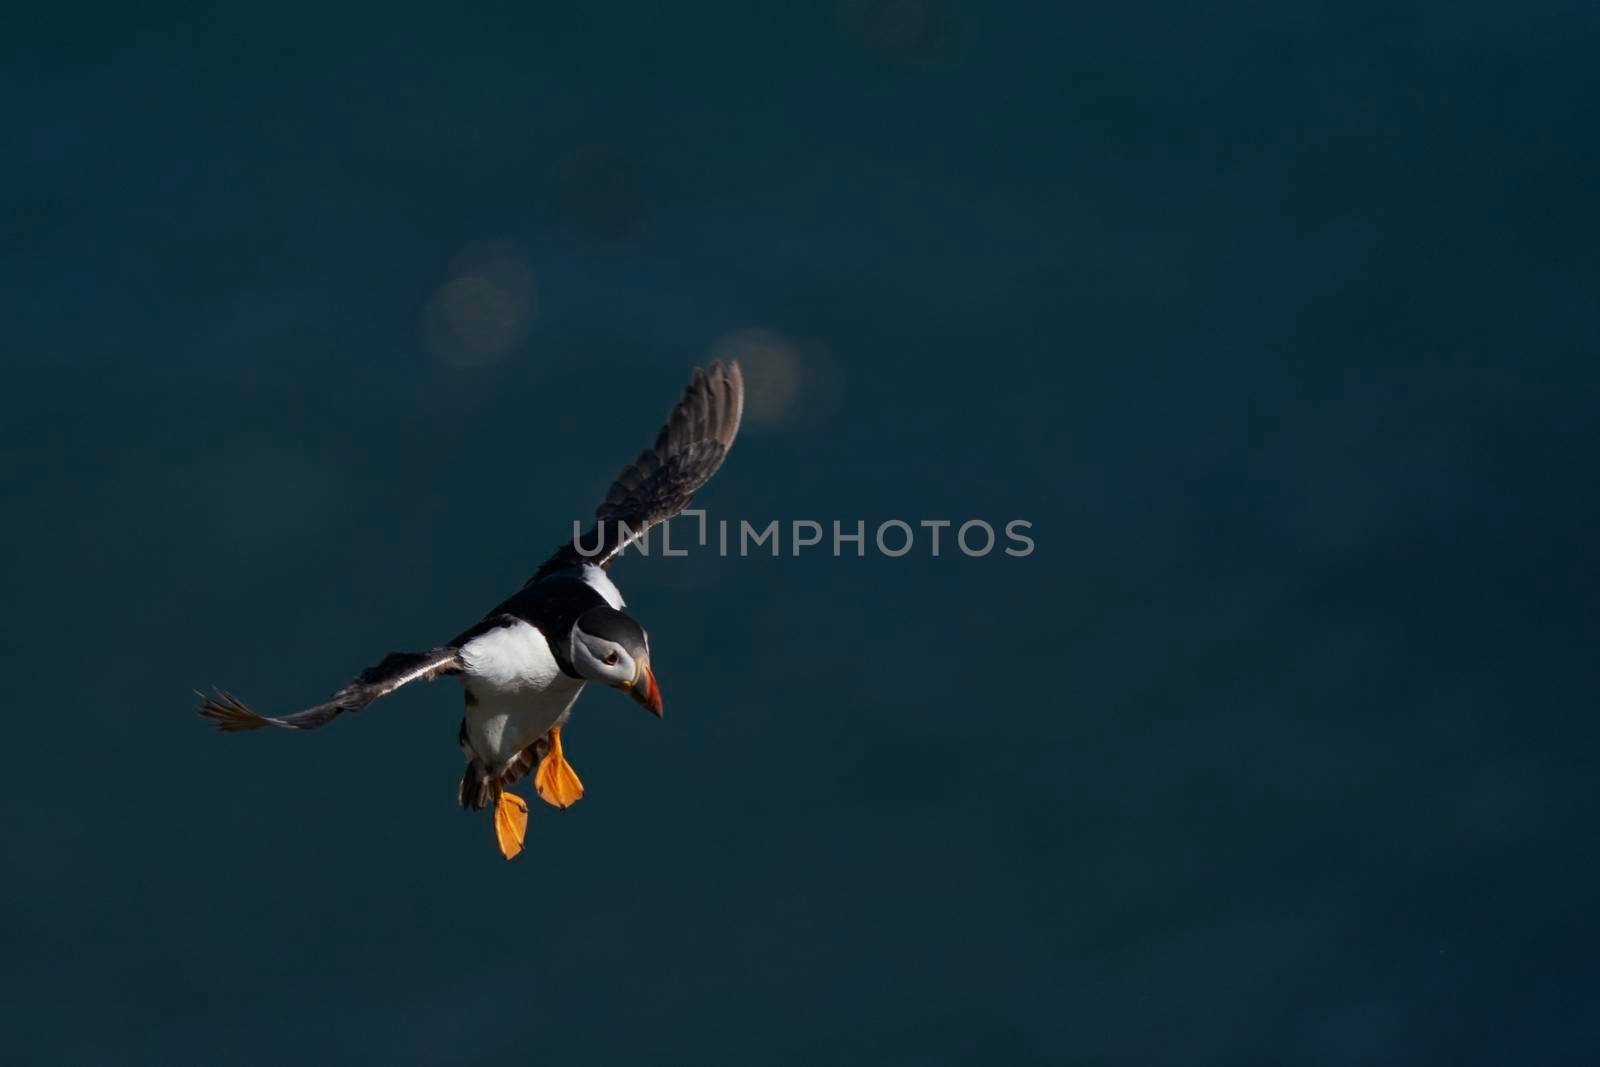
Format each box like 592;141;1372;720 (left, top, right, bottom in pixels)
198;362;744;859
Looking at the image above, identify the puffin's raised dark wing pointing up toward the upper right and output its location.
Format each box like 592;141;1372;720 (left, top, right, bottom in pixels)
528;362;744;585
